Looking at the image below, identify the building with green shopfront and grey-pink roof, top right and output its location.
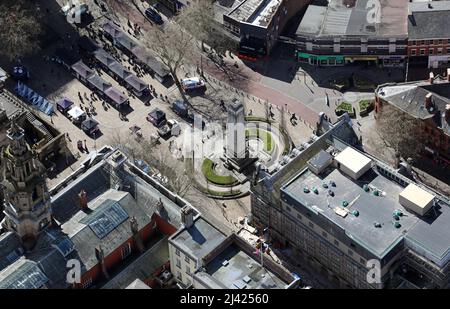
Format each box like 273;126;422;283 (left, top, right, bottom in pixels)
296;0;408;66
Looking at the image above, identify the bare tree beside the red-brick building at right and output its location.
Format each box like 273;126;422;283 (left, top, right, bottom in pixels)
376;104;423;159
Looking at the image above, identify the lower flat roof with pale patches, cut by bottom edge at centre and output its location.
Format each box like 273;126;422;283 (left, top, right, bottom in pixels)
206;243;286;289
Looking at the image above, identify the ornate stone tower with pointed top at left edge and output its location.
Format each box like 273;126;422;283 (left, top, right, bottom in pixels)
2;120;51;250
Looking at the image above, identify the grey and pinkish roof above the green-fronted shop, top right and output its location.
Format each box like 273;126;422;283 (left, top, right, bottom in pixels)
297;0;408;38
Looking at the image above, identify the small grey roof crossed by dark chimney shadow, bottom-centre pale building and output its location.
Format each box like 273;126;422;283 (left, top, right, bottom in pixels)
171;217;226;259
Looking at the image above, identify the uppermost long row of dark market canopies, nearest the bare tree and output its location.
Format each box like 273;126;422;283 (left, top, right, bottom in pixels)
102;21;170;83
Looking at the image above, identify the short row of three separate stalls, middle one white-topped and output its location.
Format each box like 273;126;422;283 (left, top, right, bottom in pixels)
56;98;99;136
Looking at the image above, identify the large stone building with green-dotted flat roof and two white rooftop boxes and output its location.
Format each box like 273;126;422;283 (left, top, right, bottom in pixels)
251;116;450;288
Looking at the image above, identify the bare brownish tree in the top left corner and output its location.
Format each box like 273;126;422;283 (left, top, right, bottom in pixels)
0;0;42;60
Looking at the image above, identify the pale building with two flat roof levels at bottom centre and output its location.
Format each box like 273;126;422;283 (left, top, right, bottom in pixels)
169;207;299;289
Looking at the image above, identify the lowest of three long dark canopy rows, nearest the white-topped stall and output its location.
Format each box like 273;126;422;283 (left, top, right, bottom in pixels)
71;60;130;109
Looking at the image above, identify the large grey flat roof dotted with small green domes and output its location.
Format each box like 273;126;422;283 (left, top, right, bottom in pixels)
282;166;419;258
